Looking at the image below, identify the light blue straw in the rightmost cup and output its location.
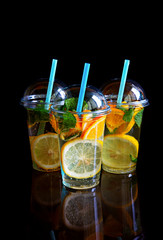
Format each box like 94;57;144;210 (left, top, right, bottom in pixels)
117;60;130;104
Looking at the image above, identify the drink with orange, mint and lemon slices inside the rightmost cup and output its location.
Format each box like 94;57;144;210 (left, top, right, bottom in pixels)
102;102;144;173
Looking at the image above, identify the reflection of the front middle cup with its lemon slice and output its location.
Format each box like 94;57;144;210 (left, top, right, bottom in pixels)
61;187;103;240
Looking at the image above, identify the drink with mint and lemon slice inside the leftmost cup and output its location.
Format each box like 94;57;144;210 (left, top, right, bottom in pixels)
27;104;60;171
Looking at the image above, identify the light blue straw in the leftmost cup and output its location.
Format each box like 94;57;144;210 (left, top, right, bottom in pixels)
45;59;58;103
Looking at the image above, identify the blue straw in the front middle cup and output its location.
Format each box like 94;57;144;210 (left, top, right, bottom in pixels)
76;63;90;112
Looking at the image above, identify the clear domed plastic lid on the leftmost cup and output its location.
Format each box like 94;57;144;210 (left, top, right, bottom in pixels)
21;78;66;107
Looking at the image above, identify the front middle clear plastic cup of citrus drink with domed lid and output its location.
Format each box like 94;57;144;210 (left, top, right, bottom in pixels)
51;86;110;189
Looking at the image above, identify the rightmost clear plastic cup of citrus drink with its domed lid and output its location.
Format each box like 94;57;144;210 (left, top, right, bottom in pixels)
101;79;149;174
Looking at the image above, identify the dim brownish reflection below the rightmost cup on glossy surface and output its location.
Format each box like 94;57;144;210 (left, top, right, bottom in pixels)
101;171;142;240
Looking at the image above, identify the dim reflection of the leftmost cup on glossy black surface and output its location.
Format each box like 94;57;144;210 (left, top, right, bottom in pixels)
31;170;61;236
